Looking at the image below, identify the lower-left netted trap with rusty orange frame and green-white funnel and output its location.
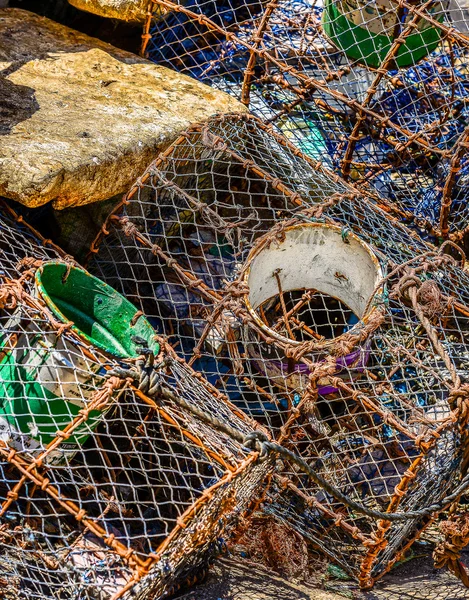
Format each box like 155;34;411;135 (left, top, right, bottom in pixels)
0;207;273;600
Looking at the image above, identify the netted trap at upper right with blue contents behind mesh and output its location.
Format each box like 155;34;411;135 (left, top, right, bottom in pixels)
142;0;469;240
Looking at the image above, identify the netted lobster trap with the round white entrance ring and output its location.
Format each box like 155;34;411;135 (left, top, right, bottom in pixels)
87;115;469;588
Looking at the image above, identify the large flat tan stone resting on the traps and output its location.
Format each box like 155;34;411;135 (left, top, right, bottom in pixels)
0;8;245;209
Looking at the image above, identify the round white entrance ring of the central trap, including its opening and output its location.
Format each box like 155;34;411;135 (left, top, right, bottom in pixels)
246;223;382;344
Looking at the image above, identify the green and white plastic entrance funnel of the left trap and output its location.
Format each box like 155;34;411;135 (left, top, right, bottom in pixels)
0;261;159;464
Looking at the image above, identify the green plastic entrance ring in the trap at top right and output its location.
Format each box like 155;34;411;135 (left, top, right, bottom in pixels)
322;0;444;67
